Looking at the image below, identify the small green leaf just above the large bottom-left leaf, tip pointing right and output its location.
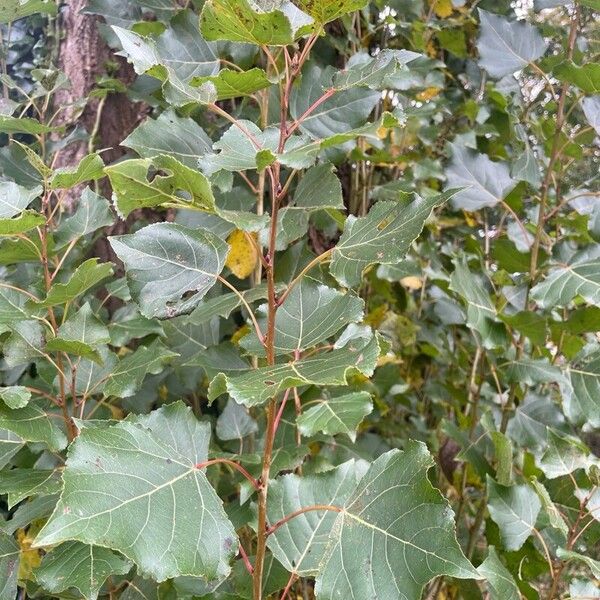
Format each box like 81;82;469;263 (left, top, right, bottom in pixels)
103;340;178;398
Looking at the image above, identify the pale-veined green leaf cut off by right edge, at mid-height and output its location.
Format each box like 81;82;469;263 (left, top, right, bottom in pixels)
531;252;600;308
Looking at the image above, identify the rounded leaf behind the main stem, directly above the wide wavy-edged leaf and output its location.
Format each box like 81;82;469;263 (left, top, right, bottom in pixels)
240;277;364;355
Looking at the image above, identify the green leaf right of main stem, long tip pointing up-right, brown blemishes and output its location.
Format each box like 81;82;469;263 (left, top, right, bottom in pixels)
330;190;456;287
